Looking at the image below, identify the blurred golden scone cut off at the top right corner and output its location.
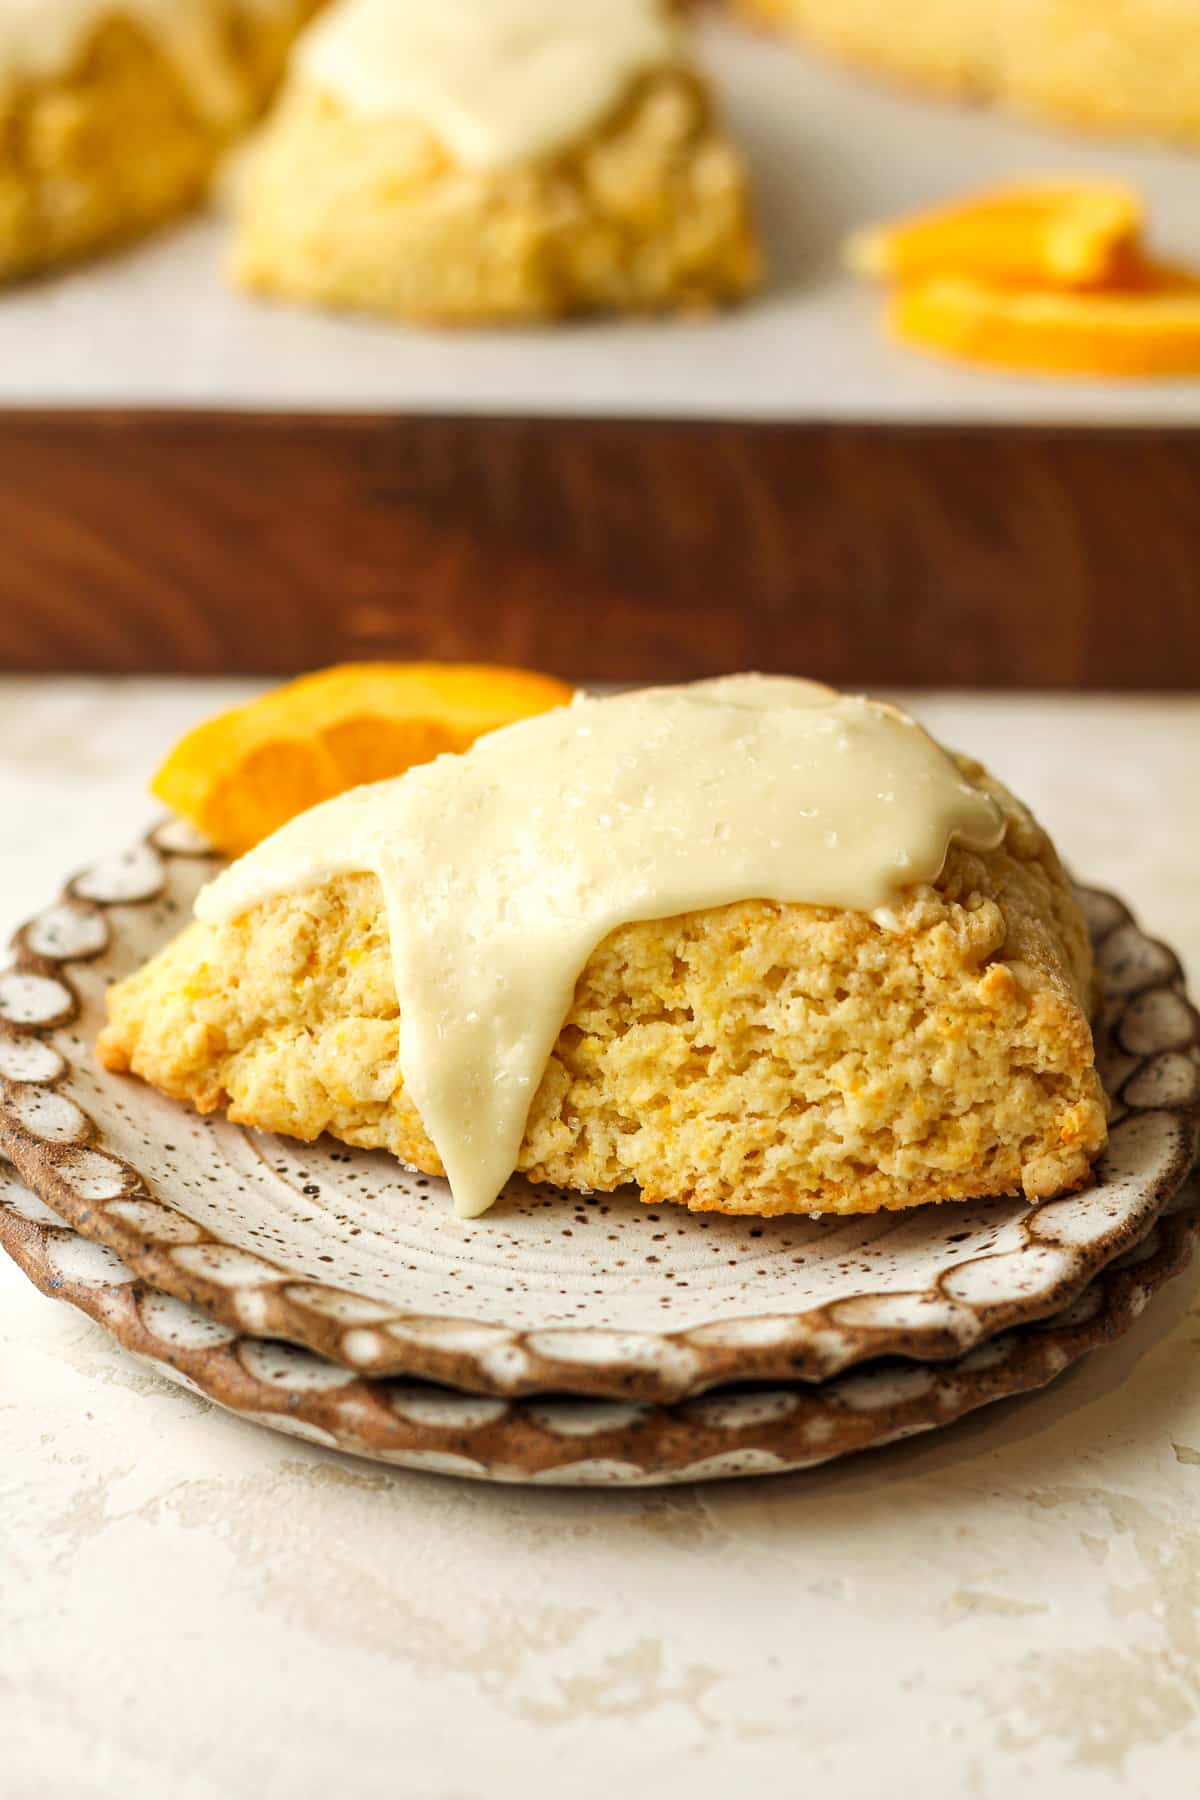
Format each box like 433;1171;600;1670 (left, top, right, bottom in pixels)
732;0;1200;142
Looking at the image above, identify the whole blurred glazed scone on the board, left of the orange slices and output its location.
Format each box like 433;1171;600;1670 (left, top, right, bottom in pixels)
234;0;759;324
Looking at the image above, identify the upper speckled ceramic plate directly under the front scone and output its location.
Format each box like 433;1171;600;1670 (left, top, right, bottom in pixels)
0;824;1200;1402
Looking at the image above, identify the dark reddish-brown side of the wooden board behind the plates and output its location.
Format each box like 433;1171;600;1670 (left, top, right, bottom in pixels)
0;412;1200;688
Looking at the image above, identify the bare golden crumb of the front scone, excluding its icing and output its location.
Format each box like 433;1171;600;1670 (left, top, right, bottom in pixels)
99;763;1106;1215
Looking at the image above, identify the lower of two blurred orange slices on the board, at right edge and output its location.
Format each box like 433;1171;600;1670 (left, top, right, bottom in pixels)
887;277;1200;376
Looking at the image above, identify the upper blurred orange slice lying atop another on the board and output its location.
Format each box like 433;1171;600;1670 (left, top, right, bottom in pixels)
846;182;1142;288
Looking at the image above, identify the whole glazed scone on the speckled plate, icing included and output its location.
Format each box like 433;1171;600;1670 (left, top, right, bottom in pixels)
99;677;1106;1215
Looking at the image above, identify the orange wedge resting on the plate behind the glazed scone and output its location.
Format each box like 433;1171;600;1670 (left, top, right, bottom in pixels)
151;662;572;857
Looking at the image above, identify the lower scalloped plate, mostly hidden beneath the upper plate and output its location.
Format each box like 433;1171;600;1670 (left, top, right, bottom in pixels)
0;1168;1200;1487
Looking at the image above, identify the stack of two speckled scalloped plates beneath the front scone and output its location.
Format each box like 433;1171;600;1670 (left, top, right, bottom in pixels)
0;824;1200;1485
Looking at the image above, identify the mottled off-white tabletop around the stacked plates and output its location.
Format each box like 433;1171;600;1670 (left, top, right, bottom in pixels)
0;680;1200;1800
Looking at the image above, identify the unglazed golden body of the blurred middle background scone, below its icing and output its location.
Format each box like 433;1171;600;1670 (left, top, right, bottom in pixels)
232;32;761;326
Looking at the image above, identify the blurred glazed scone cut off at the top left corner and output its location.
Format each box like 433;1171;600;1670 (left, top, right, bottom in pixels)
0;0;317;279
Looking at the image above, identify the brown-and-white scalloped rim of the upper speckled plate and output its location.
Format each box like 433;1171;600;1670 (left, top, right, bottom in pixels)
0;821;1200;1402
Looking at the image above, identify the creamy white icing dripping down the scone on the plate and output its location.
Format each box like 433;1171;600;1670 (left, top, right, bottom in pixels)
196;675;1004;1219
